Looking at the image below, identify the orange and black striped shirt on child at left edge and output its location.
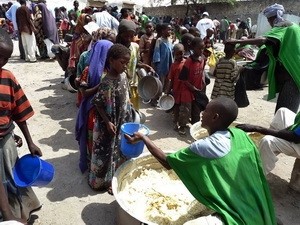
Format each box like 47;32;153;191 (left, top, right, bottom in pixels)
0;69;34;137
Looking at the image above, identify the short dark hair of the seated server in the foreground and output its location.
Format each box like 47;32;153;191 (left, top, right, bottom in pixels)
212;96;239;127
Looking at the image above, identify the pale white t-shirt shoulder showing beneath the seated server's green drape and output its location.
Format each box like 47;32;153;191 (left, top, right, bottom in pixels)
190;130;231;158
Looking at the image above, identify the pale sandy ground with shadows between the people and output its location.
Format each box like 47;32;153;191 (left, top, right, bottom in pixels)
5;40;300;225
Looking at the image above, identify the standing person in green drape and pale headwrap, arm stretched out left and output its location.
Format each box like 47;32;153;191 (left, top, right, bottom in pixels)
228;4;300;113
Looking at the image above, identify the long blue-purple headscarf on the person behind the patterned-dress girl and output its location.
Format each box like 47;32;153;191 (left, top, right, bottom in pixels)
75;40;113;173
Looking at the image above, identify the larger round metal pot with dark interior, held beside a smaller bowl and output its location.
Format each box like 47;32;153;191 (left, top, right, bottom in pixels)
138;73;163;101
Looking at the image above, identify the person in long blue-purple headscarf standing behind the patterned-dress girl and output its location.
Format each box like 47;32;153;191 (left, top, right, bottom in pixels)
75;28;114;174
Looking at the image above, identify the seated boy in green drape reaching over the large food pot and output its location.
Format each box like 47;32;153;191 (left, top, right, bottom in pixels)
126;97;276;225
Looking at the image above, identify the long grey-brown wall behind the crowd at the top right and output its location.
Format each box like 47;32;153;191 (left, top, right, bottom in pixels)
143;0;300;24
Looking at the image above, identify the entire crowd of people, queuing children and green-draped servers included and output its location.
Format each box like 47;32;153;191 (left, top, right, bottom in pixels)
0;0;300;224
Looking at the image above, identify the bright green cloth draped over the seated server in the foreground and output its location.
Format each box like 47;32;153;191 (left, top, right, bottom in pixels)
167;128;276;225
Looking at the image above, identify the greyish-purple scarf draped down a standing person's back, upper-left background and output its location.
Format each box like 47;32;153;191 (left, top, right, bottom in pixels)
38;3;59;44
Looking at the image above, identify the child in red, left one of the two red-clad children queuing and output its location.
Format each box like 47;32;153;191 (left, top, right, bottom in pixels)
167;44;186;131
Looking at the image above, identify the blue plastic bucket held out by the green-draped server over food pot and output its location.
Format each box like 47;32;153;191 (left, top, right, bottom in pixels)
121;123;149;158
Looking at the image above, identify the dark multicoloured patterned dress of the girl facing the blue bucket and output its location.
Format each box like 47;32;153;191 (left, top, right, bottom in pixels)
89;74;129;190
